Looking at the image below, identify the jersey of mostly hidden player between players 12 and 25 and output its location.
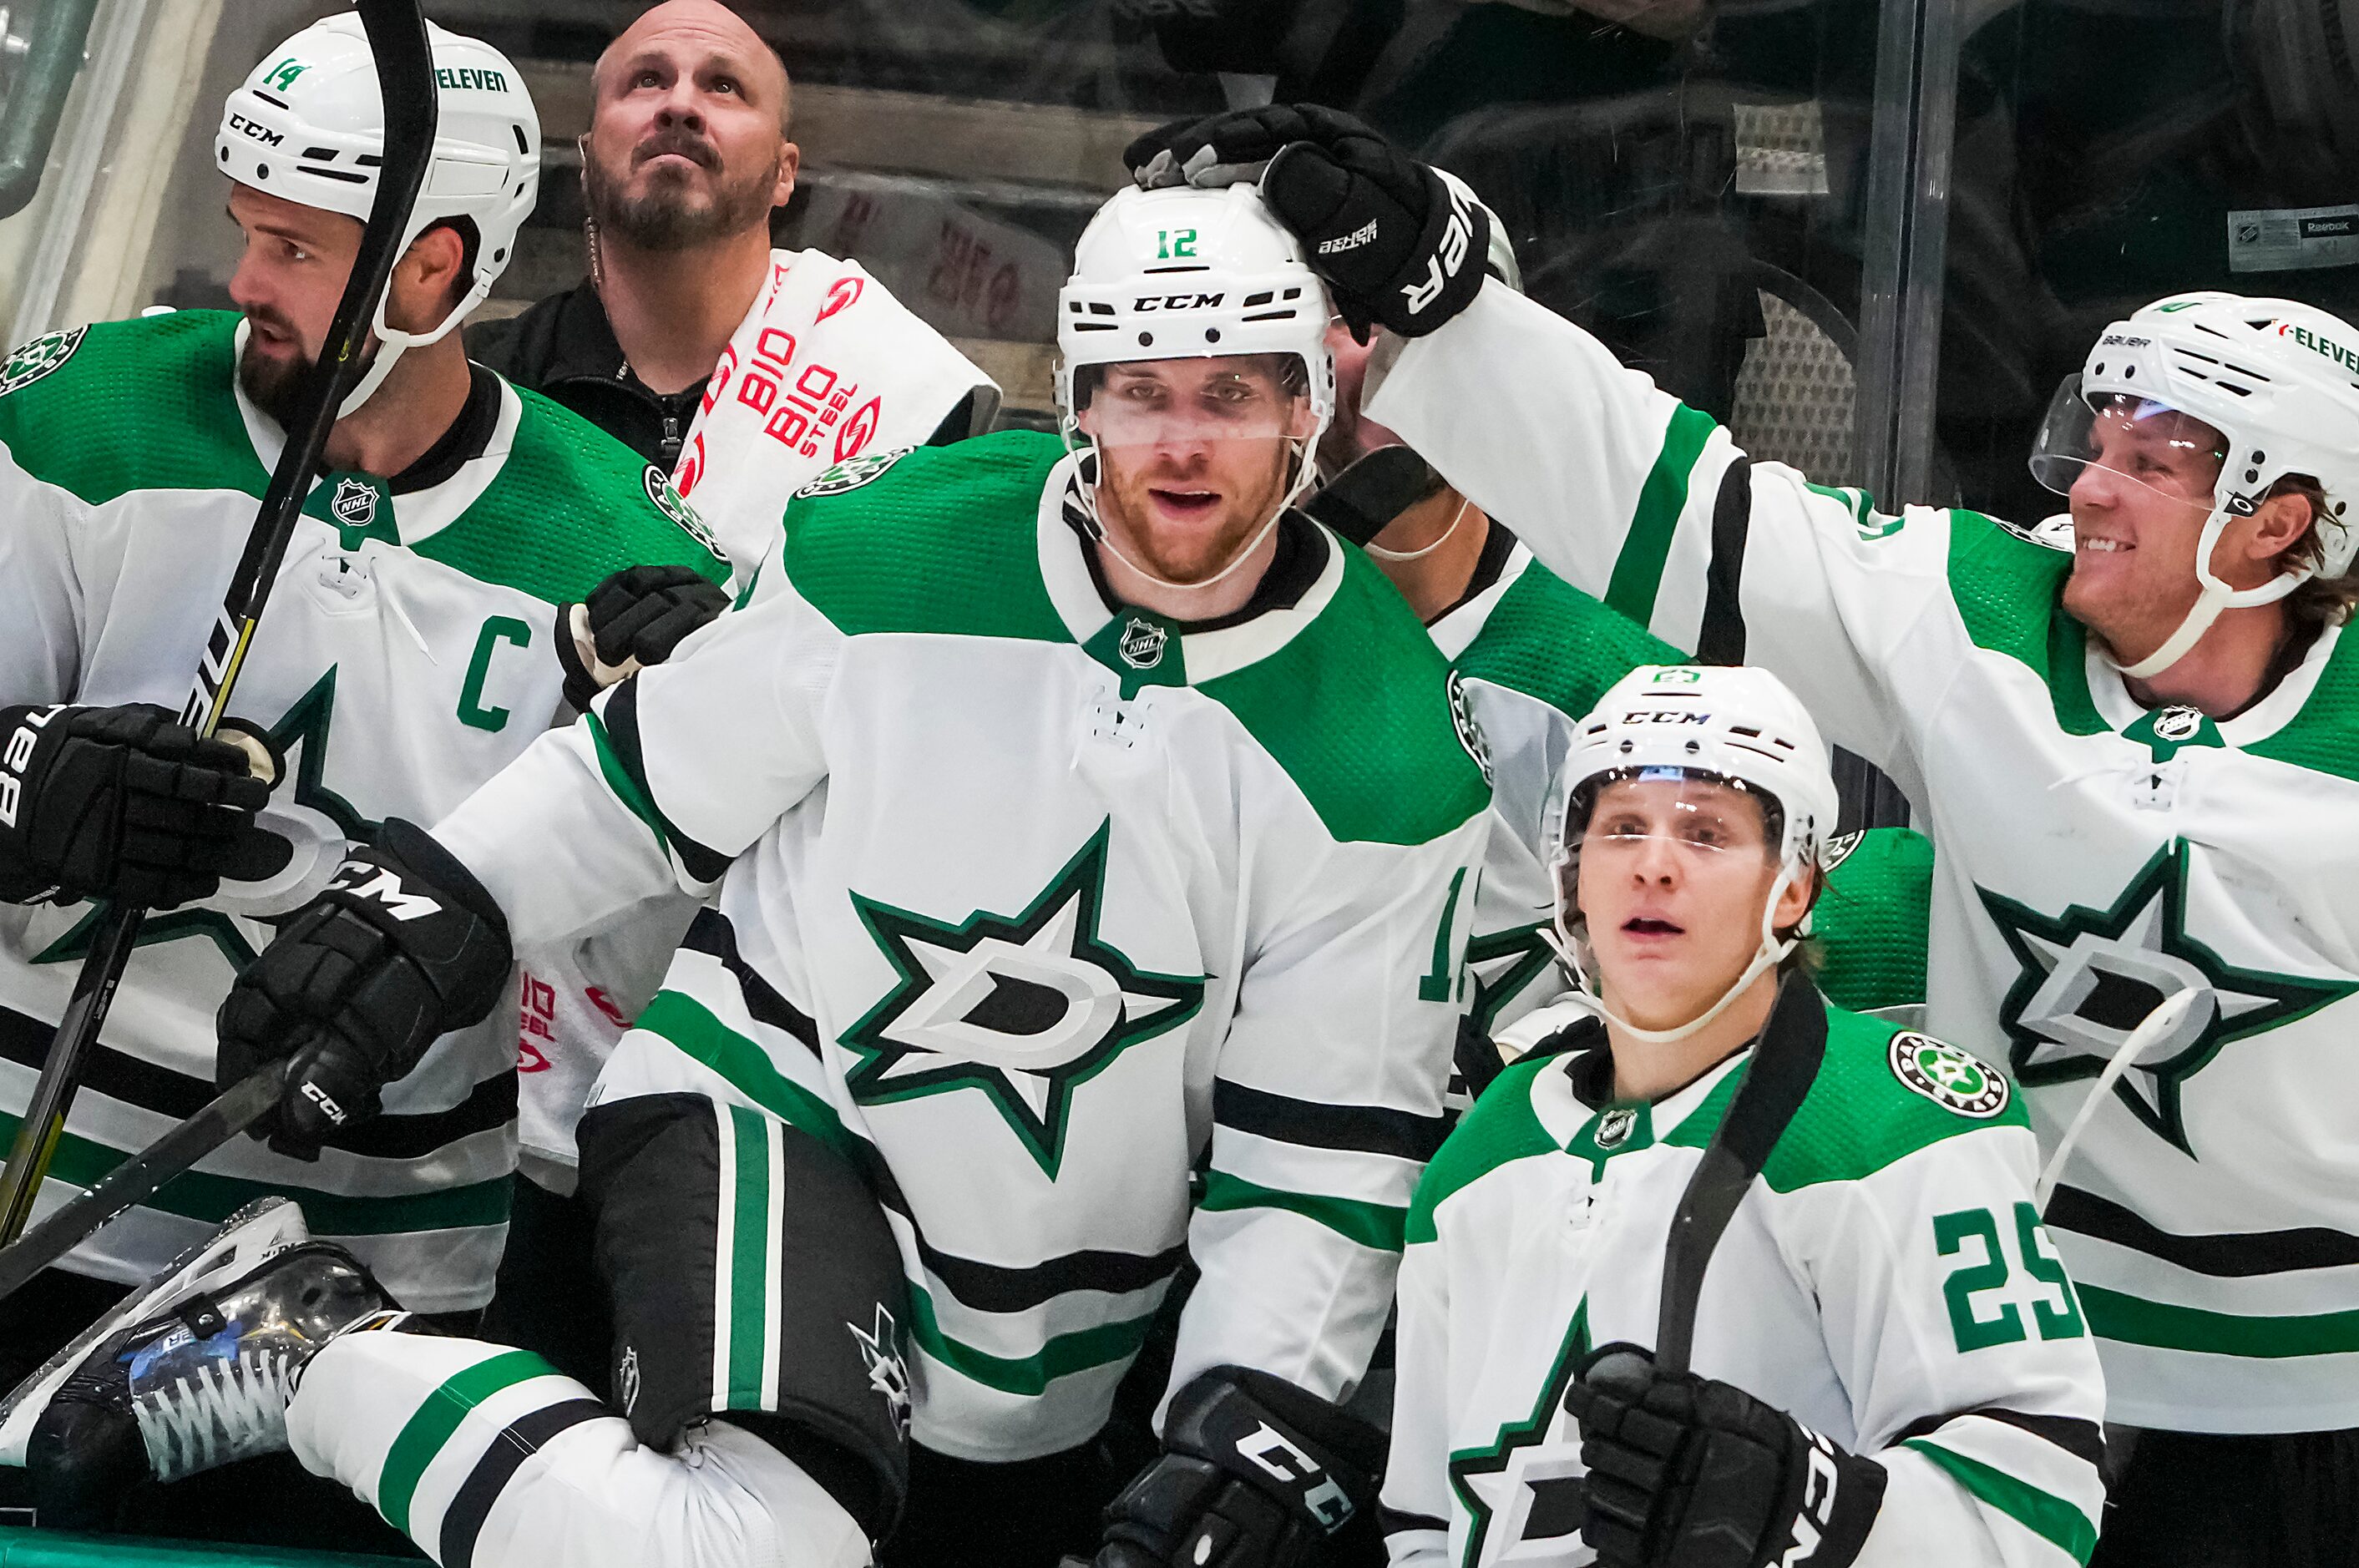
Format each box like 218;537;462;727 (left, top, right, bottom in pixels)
1427;535;1679;1039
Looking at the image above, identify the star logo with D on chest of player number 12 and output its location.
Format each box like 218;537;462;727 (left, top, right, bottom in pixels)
843;821;1206;1176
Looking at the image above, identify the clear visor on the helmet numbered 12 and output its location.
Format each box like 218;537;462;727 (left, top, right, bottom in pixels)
1076;354;1316;453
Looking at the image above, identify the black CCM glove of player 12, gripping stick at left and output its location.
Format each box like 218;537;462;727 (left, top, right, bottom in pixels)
215;818;514;1156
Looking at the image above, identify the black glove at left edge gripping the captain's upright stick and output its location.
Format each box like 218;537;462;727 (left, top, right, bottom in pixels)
0;703;292;910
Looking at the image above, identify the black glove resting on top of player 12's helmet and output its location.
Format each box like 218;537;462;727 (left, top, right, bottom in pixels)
1123;104;1491;341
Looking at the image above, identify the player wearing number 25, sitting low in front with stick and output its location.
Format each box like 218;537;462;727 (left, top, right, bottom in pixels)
1385;665;2104;1568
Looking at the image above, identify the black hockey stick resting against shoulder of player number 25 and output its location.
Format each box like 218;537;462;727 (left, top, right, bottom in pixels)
1653;972;1826;1373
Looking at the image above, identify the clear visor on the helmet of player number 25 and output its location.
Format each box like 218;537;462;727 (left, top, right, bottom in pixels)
1550;766;1784;943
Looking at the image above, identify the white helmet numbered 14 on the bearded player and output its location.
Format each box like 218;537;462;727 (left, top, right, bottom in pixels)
215;12;540;412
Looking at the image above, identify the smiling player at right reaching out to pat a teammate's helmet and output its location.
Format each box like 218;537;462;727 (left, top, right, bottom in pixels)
1127;110;2359;1565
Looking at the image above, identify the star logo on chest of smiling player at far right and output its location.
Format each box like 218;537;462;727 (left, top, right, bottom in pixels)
1975;839;2359;1158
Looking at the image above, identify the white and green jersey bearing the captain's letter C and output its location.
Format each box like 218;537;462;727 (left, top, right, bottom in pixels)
0;311;726;1311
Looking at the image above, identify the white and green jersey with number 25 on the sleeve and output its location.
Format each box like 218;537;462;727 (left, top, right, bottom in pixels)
1382;1009;2104;1568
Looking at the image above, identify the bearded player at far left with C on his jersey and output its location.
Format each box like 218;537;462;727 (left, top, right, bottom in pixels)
0;14;726;1509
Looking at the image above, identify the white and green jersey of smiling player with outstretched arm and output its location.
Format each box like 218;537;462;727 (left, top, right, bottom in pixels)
1366;286;2359;1431
